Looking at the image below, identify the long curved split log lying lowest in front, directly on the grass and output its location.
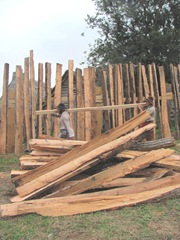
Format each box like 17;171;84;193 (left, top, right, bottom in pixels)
0;174;180;217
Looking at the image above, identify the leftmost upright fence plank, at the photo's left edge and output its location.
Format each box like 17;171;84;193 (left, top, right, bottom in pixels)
0;63;9;154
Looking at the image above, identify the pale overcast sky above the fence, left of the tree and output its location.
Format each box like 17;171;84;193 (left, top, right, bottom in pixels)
0;0;96;96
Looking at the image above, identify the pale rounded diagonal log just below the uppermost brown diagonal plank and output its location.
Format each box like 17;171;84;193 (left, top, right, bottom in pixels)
13;124;156;197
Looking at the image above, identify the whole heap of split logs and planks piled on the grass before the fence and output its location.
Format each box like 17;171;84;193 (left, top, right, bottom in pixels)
0;112;180;217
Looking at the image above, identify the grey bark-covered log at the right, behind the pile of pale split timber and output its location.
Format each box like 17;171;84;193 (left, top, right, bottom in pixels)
130;137;176;151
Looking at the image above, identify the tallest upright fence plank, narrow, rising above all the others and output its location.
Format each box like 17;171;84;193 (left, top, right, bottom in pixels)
29;50;36;138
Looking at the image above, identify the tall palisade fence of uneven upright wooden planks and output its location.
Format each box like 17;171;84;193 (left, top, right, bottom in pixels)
0;50;180;154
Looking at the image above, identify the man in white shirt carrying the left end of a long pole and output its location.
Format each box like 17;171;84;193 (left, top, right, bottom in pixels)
52;103;75;139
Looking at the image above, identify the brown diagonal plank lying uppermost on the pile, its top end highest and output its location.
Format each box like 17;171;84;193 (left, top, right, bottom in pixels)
11;111;149;188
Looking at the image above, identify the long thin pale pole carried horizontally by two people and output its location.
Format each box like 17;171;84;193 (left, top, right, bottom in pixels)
35;103;145;115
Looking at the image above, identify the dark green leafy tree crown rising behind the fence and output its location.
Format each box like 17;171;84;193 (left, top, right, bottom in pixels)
86;0;180;65
